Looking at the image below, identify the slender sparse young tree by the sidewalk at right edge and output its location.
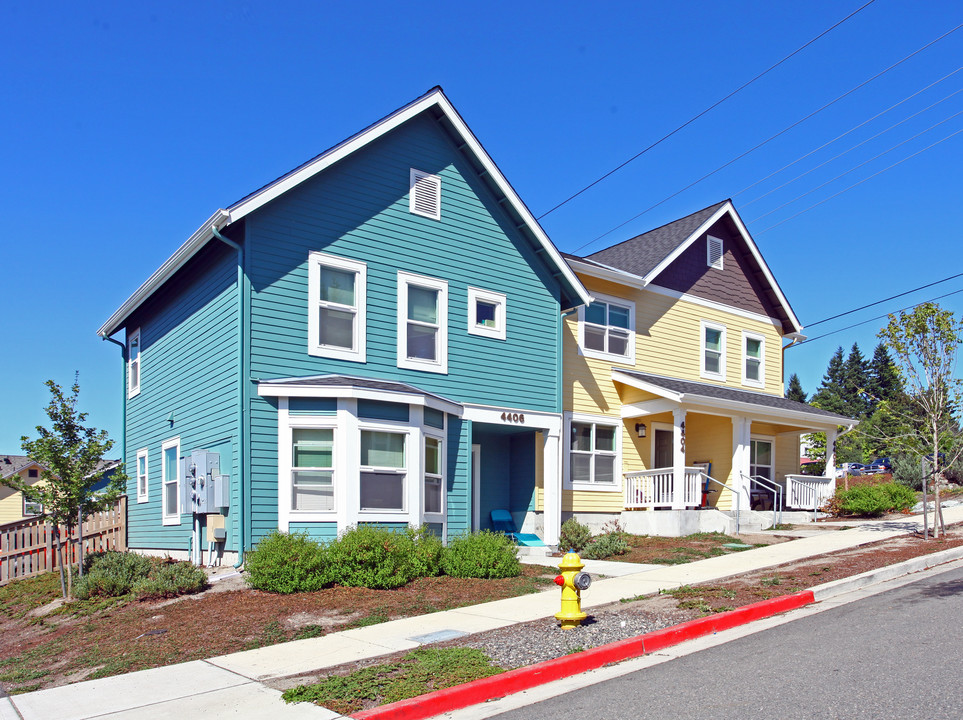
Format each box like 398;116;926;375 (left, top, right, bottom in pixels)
878;302;963;537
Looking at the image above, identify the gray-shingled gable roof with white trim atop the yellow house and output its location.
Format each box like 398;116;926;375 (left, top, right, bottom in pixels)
567;200;802;334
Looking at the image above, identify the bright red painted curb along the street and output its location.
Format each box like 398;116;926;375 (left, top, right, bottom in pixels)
351;590;816;720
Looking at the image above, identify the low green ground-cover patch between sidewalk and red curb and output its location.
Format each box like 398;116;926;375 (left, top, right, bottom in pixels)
282;648;505;715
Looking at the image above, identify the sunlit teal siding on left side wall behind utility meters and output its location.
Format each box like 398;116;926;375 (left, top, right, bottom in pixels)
125;243;238;551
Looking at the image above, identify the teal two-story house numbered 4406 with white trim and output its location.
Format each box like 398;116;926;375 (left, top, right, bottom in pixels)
98;88;590;558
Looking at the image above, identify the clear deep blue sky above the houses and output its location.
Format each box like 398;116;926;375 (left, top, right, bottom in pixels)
0;0;963;453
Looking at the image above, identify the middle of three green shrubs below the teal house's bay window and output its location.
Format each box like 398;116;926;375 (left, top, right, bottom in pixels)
328;525;427;590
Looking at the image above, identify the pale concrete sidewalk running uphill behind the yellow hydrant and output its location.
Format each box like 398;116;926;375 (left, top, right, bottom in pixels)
0;506;963;720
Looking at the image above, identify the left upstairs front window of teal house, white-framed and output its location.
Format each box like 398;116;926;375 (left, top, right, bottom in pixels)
308;252;367;362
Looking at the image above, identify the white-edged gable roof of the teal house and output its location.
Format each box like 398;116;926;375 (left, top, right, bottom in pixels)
97;87;592;337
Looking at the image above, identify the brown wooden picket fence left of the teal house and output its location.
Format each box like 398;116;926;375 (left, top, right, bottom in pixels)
0;496;127;585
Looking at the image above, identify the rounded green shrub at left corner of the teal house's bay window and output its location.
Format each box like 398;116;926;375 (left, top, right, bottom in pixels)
244;530;334;594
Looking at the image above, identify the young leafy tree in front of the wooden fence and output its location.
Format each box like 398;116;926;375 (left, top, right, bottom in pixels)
3;378;127;598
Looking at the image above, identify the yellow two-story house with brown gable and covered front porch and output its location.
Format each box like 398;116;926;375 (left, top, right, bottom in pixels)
561;200;855;535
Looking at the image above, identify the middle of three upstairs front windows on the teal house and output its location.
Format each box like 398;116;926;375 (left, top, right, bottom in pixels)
398;272;448;373
